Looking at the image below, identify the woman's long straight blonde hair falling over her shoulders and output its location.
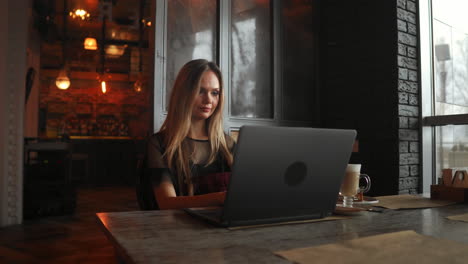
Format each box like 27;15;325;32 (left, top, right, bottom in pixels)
160;59;233;192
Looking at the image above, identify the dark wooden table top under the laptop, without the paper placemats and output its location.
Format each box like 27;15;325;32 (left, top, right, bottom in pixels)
97;204;468;263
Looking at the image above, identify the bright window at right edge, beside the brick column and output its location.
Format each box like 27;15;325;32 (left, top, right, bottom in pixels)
420;0;468;192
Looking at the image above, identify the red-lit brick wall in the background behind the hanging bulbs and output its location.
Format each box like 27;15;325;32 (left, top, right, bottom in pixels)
39;36;153;137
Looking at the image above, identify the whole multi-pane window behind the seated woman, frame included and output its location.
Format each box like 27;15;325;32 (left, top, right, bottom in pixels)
154;0;319;132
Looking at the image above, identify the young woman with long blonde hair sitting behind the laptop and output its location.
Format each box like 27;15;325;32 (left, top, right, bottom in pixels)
147;59;234;209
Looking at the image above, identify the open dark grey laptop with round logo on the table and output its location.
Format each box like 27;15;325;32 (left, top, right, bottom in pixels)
186;126;356;227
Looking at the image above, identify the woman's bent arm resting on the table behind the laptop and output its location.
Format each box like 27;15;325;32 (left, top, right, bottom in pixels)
154;181;226;210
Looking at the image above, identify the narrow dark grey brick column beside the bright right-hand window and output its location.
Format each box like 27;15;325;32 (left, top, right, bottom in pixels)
397;0;420;194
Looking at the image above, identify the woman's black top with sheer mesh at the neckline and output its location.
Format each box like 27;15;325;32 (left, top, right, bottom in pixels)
147;132;235;195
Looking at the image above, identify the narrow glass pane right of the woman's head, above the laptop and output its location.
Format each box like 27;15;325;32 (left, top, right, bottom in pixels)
230;0;273;118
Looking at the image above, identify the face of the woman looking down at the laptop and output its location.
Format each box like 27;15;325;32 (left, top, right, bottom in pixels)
192;71;221;120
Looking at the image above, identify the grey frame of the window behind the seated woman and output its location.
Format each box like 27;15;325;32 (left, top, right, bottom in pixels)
153;0;317;135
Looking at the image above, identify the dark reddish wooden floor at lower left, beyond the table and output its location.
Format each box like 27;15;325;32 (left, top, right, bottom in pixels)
0;187;138;264
